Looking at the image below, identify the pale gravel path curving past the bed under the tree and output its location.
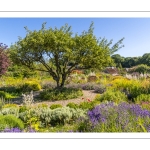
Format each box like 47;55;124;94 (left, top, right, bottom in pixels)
34;90;97;106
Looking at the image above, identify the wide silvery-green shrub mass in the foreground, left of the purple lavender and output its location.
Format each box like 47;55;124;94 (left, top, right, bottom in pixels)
19;107;86;127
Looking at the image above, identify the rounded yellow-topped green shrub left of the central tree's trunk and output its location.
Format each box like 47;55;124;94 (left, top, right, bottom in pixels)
20;81;41;92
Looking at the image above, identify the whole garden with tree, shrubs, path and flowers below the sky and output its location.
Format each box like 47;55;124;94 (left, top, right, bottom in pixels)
0;23;150;133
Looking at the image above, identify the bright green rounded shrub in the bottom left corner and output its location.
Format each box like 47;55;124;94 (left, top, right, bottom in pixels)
0;115;24;131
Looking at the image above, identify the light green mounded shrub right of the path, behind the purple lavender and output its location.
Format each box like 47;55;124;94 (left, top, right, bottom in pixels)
96;89;127;103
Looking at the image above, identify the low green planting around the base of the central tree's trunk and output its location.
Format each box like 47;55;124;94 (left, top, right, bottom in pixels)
40;88;83;101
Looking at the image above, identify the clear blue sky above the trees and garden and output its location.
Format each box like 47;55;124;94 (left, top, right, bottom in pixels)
0;18;150;57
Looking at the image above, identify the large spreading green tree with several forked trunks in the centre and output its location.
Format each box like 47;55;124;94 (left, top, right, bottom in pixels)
10;23;123;88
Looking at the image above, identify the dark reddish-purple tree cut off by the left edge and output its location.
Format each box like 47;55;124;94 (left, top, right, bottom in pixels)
0;43;10;77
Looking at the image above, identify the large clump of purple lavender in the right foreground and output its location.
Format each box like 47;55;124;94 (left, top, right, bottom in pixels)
78;102;150;132
